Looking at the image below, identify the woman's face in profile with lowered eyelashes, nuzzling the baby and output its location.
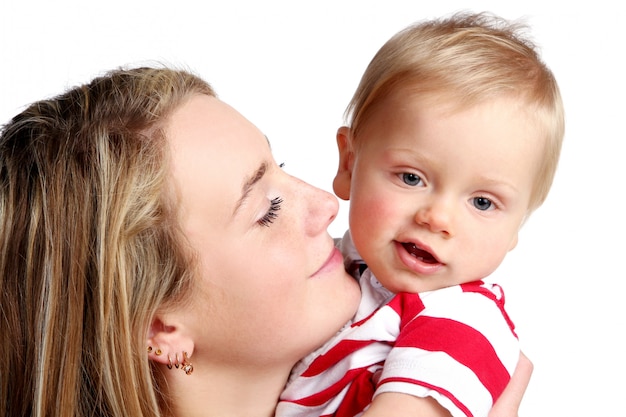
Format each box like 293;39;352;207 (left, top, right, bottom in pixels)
168;95;359;366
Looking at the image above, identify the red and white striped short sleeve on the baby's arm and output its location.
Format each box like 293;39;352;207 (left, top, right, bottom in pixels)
375;281;520;417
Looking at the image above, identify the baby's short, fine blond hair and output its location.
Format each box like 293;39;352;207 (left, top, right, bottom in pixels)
346;12;564;213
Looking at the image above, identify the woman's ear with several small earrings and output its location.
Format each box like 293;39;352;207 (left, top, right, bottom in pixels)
146;315;194;366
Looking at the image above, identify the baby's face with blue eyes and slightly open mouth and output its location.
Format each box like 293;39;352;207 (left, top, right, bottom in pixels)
338;94;543;292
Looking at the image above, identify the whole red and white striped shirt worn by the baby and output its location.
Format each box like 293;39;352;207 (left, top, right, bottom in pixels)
276;234;520;417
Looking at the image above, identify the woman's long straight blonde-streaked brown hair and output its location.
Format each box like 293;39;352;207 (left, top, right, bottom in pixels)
0;68;214;417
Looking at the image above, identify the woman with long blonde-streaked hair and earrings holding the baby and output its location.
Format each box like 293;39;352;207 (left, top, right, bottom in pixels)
0;68;530;417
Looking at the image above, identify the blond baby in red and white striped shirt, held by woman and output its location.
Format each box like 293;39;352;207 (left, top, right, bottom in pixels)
276;13;564;417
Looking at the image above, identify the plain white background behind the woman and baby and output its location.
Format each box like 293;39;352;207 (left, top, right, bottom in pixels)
0;0;626;417
